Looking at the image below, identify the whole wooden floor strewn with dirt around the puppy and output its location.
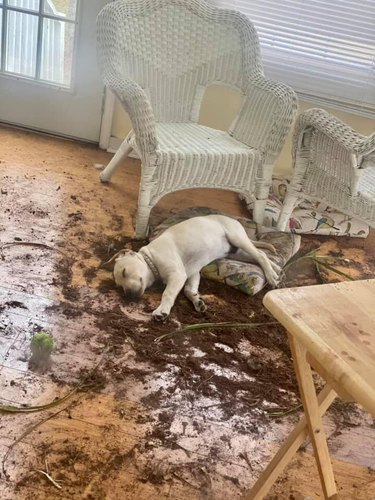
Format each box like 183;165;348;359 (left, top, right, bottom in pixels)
0;124;375;500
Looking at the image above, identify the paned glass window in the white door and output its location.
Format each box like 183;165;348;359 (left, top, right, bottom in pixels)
0;0;78;88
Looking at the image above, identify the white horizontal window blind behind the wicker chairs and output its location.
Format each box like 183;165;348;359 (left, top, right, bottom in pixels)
213;0;375;117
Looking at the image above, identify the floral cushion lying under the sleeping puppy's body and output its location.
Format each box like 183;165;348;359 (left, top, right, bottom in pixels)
150;207;301;295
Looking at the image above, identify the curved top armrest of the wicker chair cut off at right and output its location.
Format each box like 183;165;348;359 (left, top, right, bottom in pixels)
293;108;375;157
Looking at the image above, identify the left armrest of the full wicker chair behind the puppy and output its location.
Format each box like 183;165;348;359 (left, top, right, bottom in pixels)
104;71;158;155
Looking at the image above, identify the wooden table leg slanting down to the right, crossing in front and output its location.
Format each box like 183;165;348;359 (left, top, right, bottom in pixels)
288;333;337;499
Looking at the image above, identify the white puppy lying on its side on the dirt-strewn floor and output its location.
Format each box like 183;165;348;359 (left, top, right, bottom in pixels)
106;215;281;321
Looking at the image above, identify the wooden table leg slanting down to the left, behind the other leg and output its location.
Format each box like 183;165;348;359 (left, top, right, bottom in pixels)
244;384;336;500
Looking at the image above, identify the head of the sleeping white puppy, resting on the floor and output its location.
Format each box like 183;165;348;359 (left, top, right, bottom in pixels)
106;250;147;299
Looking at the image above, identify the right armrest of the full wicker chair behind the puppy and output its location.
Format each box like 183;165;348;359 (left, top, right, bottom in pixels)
232;73;297;165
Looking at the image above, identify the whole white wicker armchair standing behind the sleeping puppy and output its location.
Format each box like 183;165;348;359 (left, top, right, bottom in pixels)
97;0;296;238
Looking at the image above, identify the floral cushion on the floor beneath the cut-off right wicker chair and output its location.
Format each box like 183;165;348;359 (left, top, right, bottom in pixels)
240;177;369;238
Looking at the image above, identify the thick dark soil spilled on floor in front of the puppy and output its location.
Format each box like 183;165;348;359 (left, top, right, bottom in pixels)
20;231;374;498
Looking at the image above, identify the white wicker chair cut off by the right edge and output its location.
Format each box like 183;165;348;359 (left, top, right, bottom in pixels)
277;108;375;231
